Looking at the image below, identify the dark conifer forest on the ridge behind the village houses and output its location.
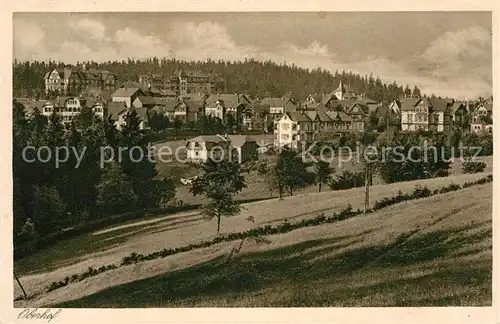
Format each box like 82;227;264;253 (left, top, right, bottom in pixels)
13;57;421;101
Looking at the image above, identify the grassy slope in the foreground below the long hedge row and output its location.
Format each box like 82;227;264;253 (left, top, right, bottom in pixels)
43;185;492;308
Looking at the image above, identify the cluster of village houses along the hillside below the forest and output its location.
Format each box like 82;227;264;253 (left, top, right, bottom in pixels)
15;64;493;158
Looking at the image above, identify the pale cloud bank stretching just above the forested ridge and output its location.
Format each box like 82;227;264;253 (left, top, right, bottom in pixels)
14;19;492;98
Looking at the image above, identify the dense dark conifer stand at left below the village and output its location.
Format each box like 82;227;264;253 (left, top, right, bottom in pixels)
13;101;175;243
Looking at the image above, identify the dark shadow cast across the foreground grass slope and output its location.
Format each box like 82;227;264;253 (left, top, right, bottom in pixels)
52;226;491;308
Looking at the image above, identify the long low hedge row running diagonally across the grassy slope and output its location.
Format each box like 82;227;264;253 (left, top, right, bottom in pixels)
47;175;493;292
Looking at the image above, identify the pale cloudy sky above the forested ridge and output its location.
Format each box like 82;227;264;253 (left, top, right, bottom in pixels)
13;12;492;99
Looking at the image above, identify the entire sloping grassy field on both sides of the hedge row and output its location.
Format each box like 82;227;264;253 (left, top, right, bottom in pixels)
16;174;492;307
